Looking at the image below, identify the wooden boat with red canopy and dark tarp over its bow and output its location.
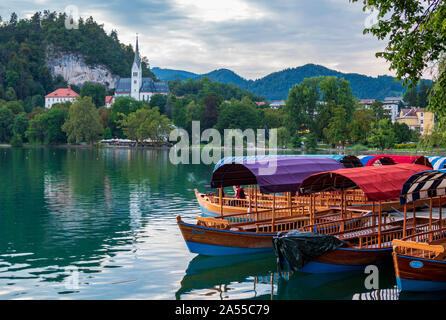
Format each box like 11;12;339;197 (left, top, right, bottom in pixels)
274;164;436;273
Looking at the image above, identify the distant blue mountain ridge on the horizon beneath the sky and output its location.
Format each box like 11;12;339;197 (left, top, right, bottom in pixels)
151;64;405;100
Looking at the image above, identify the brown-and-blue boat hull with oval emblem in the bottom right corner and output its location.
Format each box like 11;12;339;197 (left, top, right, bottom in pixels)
393;253;446;291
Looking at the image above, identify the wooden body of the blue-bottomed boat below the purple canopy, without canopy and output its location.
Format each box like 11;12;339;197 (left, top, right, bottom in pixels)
177;208;370;256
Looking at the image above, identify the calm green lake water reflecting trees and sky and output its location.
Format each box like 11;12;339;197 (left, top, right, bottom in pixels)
0;148;438;300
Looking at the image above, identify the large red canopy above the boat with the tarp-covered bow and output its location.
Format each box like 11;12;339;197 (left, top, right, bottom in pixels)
300;163;430;201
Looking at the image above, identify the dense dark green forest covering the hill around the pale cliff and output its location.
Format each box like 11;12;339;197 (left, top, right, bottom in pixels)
0;11;155;109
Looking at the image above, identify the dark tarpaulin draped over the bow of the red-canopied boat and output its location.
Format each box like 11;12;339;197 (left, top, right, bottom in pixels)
273;230;347;271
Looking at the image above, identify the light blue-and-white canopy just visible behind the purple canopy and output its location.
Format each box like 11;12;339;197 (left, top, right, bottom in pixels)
214;154;363;171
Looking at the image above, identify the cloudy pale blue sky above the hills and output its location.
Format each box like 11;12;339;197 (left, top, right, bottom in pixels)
0;0;393;79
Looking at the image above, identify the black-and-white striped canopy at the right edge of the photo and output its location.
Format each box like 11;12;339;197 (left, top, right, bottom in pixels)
400;169;446;204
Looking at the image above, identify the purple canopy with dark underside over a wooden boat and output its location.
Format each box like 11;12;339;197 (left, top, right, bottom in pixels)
211;157;344;193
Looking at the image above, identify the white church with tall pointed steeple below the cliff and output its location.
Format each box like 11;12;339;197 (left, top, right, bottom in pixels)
113;38;169;101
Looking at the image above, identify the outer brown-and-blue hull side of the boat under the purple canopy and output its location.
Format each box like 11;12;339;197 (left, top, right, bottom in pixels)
178;221;276;256
